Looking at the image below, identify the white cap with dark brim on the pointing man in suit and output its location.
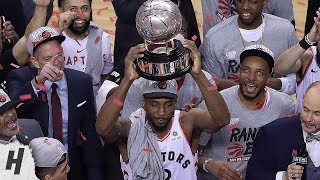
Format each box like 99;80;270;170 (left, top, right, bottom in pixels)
27;26;66;56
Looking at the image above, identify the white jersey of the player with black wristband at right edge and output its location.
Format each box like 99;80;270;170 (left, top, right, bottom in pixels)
296;46;320;113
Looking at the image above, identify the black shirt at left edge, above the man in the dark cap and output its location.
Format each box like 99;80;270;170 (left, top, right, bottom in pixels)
0;49;18;83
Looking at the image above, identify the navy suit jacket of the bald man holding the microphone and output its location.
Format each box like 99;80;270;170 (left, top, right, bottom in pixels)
246;115;305;180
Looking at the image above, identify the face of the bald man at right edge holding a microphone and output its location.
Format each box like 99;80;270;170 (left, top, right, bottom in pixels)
300;87;320;133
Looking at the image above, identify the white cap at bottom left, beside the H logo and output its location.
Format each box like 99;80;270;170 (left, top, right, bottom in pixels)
29;137;67;167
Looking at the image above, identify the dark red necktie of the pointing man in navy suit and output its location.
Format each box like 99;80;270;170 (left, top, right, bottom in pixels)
51;83;63;143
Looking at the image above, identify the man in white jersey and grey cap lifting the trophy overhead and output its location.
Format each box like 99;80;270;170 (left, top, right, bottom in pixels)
96;40;229;180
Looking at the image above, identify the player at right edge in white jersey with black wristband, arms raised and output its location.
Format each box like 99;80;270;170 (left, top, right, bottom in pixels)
274;9;320;113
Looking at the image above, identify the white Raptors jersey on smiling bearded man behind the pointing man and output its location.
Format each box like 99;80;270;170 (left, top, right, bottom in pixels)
61;32;113;75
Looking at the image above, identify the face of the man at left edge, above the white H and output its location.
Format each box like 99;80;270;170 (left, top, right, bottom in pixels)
0;107;19;141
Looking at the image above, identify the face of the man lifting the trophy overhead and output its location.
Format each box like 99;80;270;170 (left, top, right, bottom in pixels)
144;98;176;132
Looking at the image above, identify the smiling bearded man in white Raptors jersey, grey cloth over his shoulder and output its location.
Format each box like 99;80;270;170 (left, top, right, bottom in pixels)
58;0;113;96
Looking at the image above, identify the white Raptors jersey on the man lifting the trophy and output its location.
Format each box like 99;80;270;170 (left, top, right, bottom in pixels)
158;110;197;180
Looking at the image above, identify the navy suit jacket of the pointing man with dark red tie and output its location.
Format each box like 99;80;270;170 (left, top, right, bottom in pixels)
7;67;102;180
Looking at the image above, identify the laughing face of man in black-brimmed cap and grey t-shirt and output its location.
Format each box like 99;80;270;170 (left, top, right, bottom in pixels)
239;56;270;100
